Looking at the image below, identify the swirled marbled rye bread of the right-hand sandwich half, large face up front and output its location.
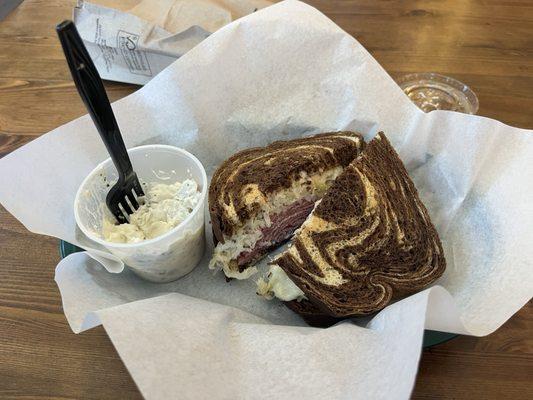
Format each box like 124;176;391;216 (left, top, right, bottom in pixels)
274;133;446;320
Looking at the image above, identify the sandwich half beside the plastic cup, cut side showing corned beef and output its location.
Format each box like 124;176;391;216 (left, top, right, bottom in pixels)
208;132;364;279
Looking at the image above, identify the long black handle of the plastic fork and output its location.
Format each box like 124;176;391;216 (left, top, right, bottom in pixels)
56;20;133;180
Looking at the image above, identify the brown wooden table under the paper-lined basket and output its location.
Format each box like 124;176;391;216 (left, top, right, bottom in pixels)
0;0;533;399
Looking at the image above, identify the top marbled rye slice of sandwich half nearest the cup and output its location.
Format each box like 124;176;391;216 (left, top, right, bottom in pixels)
208;132;364;243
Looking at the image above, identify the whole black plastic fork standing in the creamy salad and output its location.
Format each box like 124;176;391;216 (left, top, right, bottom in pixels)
56;20;144;224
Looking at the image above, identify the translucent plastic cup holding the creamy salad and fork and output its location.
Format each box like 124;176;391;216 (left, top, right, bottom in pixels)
74;145;207;282
